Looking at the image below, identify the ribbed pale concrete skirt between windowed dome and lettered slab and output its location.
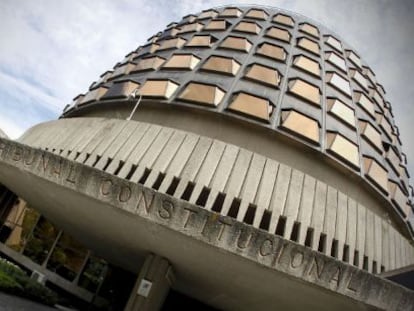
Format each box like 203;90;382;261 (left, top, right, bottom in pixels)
9;118;414;273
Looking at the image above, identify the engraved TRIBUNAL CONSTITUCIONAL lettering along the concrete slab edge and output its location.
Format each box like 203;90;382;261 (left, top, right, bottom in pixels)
0;142;368;302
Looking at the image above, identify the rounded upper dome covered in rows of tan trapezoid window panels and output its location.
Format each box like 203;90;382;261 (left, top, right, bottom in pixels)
62;7;413;251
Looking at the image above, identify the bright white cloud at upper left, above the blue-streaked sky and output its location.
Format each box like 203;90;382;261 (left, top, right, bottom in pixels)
0;0;170;105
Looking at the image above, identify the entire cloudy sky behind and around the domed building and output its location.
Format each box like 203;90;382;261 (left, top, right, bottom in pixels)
0;0;414;179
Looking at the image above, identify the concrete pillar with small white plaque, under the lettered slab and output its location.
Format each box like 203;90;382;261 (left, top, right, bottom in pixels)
124;254;174;311
